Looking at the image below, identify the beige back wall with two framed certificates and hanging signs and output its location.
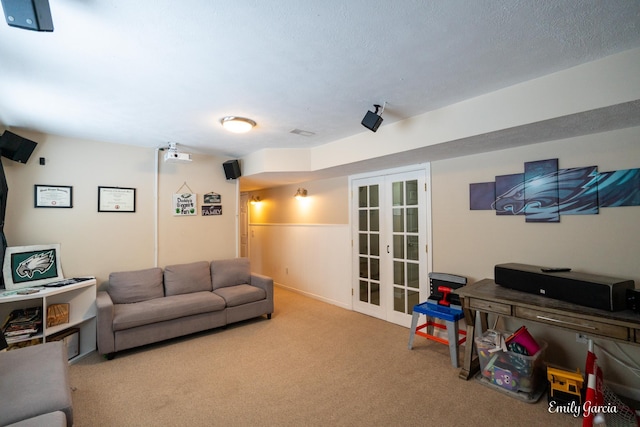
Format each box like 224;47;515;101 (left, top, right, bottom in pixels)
2;131;237;290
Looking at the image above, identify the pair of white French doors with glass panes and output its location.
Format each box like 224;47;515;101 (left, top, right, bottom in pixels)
351;170;428;327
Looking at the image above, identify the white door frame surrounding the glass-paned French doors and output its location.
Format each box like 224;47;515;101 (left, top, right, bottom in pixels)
349;163;433;327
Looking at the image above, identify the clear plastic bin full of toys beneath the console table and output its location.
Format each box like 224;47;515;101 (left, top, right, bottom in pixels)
475;329;547;393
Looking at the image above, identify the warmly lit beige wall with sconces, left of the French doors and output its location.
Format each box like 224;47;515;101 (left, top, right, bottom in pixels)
249;177;351;309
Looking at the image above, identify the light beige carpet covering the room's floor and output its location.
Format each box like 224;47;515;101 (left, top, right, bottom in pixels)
70;288;582;427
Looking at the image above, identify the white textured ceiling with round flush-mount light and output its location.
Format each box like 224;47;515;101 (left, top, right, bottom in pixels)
0;0;640;186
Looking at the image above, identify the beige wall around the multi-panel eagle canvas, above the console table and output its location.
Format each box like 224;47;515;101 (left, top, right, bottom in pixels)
432;128;640;284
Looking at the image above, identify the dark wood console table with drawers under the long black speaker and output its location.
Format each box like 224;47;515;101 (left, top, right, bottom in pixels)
456;279;640;380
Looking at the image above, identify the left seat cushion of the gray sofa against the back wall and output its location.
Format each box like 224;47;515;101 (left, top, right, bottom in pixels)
113;292;225;331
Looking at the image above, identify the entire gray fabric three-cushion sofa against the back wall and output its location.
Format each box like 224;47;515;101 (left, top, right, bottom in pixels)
96;258;273;358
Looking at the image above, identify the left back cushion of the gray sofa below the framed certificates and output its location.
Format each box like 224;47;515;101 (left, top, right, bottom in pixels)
108;267;164;304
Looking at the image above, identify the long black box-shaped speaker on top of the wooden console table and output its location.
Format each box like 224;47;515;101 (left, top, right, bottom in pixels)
494;263;635;311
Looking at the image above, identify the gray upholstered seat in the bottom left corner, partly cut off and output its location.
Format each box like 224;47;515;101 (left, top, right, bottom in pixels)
0;341;73;427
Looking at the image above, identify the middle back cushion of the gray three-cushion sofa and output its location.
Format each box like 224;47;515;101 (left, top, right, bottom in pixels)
164;261;211;296
